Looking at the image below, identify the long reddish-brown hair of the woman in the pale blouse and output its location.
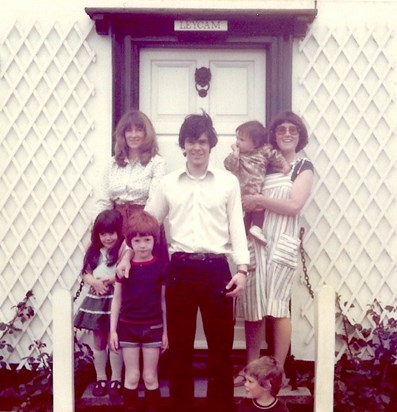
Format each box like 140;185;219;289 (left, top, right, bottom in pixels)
114;110;159;167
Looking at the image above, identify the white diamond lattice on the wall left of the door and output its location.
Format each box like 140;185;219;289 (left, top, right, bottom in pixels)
0;22;95;362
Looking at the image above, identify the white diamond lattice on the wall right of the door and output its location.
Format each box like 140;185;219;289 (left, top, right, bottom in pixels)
298;27;397;356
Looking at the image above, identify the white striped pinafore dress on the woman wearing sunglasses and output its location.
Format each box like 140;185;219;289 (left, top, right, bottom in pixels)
240;158;313;321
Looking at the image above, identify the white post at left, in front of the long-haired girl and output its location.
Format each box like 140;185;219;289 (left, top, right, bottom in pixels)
52;289;74;412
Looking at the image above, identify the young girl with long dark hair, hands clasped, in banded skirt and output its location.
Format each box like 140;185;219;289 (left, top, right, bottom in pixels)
74;209;123;396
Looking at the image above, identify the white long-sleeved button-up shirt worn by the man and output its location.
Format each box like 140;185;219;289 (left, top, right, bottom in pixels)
145;166;249;265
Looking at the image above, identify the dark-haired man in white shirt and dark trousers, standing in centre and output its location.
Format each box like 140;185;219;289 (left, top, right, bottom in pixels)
119;113;249;412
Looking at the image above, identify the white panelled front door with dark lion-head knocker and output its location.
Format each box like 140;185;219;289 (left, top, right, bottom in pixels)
139;48;266;348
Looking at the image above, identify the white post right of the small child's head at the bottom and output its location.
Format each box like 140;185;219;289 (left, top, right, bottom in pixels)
314;286;335;412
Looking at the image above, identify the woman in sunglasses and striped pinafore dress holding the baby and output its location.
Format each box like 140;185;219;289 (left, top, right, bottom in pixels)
235;112;313;374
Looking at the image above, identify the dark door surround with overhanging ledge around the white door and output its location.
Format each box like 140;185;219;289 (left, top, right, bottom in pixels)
85;8;317;129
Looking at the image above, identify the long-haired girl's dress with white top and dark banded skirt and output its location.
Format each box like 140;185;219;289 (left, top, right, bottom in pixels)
74;248;116;331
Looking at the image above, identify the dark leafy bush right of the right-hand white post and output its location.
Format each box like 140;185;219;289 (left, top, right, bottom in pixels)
335;296;397;412
